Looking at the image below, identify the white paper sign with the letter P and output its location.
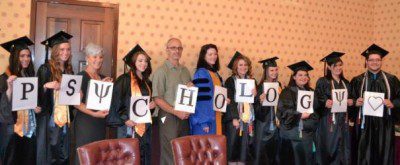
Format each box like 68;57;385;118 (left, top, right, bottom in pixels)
12;77;38;111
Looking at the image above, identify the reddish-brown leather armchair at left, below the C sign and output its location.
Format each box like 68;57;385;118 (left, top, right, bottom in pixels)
77;138;140;165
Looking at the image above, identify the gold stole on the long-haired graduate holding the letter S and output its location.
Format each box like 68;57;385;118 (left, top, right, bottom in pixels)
53;90;70;127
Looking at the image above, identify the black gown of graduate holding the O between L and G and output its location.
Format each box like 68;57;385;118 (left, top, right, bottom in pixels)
253;83;280;165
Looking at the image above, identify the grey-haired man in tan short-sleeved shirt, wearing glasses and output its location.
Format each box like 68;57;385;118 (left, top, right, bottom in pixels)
152;38;191;165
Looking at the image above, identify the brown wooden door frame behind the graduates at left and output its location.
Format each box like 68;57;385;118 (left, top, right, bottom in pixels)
30;0;119;80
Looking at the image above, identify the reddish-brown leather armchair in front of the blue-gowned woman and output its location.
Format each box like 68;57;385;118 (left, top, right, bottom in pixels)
171;135;227;165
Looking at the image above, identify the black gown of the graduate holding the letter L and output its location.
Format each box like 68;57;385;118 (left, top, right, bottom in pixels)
222;76;252;162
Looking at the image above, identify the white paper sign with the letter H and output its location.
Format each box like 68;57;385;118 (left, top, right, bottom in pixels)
174;84;199;113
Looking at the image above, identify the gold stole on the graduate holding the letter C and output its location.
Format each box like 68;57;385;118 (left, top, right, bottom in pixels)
131;71;151;137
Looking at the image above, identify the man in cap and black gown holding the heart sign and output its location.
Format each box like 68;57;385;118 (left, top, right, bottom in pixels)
351;44;400;165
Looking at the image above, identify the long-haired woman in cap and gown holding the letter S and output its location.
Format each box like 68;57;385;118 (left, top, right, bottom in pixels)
37;31;73;164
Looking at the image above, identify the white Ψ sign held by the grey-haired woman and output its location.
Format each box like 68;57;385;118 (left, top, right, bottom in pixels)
86;79;114;111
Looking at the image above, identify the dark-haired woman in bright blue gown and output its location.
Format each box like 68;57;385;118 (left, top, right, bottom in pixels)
189;44;222;135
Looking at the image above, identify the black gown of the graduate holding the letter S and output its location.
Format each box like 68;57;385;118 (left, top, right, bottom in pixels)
36;63;73;164
